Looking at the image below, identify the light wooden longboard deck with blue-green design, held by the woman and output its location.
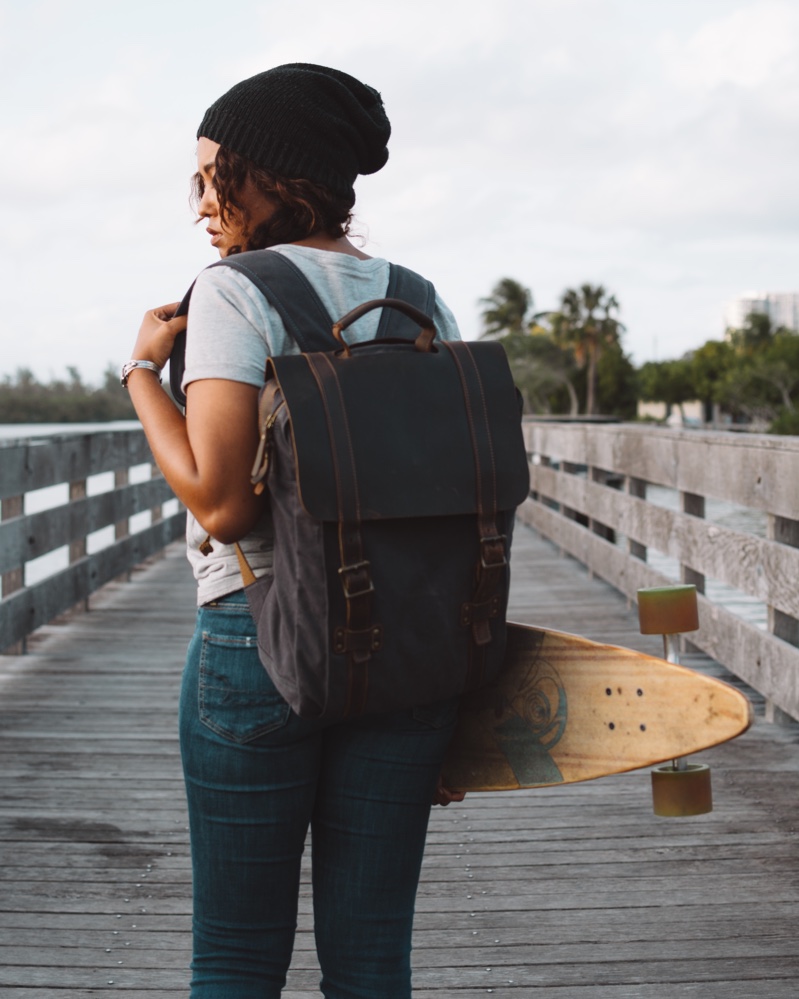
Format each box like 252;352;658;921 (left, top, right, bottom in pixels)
442;624;752;791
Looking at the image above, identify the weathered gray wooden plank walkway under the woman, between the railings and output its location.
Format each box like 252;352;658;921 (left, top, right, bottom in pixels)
0;527;799;999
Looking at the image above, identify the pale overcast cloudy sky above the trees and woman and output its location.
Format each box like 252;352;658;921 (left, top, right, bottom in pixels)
0;0;799;380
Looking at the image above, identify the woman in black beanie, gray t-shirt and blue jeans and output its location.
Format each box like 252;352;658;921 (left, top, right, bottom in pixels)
123;64;458;999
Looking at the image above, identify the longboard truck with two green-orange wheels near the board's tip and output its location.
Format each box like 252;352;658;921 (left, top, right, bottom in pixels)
638;585;713;818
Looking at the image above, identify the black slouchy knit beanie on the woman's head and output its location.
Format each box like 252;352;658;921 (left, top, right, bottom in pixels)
197;62;391;197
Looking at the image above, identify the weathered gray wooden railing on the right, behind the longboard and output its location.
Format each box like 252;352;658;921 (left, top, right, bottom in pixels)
520;421;799;720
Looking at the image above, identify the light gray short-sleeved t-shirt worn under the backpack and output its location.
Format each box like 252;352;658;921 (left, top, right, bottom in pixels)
183;245;460;604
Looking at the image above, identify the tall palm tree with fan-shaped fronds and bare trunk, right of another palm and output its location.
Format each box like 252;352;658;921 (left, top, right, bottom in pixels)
549;284;624;416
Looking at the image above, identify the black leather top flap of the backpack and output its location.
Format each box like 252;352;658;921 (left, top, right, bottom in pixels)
269;341;529;521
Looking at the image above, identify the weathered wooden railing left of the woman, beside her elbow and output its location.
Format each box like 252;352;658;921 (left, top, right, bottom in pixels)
0;429;185;651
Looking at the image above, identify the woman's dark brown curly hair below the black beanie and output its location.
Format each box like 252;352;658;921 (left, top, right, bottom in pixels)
192;146;355;253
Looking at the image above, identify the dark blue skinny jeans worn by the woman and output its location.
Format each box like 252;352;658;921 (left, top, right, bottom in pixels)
180;592;457;999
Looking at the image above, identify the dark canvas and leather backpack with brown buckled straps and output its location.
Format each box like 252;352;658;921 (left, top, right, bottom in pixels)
170;250;529;720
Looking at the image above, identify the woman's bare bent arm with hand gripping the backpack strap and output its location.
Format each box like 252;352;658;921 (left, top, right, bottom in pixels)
128;304;263;544
